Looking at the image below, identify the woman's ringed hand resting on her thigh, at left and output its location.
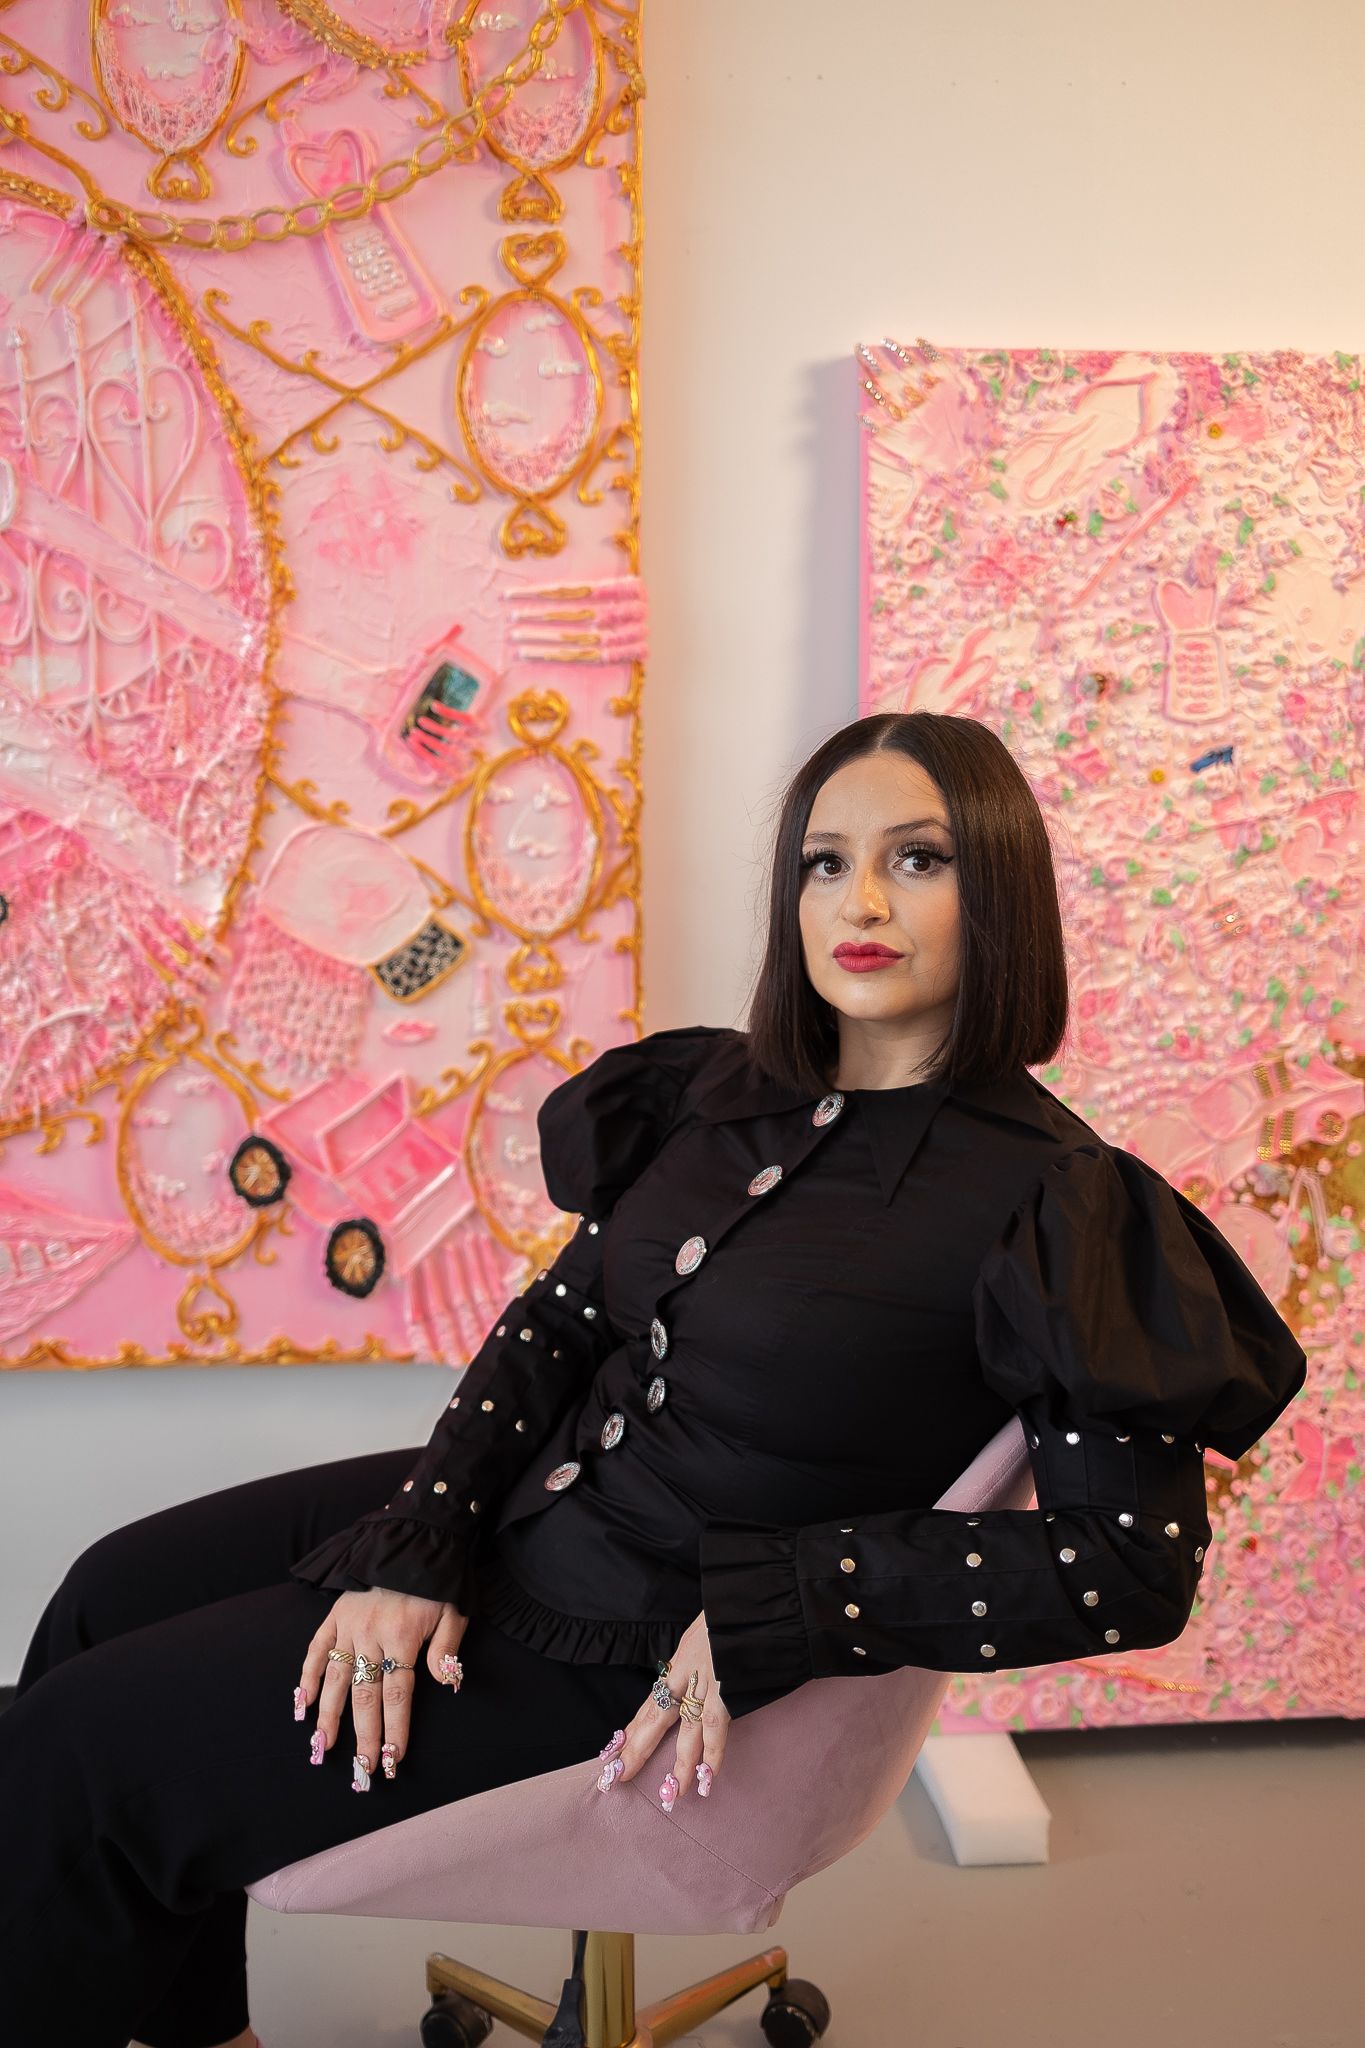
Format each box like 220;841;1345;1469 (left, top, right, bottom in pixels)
295;1585;469;1792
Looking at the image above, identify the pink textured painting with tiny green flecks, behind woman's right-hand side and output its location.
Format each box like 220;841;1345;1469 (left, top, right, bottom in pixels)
857;340;1365;1733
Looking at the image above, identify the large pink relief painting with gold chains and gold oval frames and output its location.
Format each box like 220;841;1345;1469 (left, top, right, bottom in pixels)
0;0;645;1368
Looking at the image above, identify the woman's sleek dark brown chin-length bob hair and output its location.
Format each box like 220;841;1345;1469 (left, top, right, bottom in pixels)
747;711;1068;1096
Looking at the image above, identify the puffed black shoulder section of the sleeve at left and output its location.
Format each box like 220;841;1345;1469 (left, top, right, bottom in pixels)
536;1024;747;1217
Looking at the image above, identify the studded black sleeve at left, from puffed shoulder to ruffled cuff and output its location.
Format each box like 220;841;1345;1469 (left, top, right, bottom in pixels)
291;1026;718;1614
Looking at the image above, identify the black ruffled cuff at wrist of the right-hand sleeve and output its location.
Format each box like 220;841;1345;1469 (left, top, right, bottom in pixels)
700;1522;814;1692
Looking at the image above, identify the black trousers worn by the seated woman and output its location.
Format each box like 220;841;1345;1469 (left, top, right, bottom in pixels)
0;1448;736;2048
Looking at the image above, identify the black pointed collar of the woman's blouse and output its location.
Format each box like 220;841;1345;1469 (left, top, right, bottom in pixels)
696;1044;1056;1202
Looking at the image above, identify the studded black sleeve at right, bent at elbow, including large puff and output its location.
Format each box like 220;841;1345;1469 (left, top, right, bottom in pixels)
702;1141;1308;1690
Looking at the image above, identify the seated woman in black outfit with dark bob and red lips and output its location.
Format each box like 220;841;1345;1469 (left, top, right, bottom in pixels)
0;713;1304;2048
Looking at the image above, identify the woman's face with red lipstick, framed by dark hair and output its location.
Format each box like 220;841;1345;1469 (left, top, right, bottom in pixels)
800;752;958;1085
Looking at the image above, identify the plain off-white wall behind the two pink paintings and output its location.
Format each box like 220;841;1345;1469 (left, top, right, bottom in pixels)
0;0;1365;1681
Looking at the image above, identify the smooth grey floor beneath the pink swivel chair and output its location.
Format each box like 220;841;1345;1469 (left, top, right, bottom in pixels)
240;1720;1365;2048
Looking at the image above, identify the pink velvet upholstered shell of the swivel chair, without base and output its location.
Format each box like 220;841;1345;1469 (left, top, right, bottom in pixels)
248;1417;1033;1933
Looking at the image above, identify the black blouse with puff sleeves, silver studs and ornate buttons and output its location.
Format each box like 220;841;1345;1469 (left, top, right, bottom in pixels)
293;1024;1306;1696
